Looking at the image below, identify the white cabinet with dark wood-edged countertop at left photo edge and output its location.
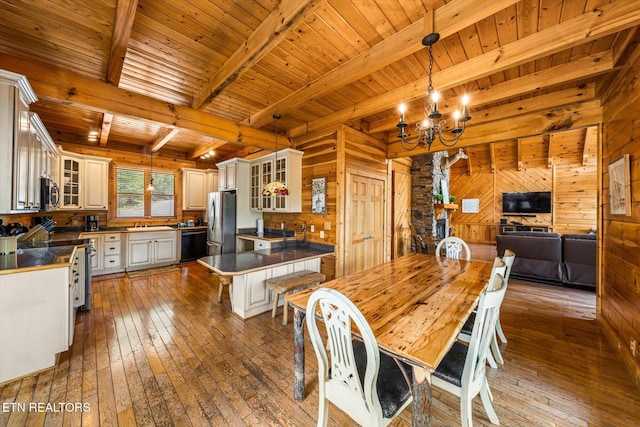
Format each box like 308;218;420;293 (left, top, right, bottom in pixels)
0;245;78;383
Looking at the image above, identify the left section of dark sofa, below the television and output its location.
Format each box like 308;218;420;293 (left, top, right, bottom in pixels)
496;231;563;282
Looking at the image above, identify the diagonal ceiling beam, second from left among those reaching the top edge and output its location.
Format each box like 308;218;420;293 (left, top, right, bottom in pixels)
192;0;326;109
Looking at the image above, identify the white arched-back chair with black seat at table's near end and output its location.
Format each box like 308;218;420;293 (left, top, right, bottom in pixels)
306;288;412;426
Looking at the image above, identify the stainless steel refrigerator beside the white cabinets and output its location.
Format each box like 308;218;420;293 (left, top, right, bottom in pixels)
207;191;236;255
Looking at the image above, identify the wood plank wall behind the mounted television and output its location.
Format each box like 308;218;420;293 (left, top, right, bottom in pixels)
449;129;597;244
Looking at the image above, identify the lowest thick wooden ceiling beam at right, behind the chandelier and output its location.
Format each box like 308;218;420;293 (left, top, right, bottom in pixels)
387;100;602;158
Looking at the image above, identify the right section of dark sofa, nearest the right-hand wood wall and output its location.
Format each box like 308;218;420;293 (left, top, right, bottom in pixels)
562;234;597;287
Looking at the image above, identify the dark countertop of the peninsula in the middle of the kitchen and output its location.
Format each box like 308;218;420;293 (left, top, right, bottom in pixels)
198;247;334;276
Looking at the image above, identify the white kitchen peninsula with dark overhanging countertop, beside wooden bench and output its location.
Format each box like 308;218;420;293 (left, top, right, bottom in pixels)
198;244;333;319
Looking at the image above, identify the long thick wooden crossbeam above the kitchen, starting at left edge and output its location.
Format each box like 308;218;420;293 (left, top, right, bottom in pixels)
0;53;290;150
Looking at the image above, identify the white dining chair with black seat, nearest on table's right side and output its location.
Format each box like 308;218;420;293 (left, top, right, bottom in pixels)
431;274;507;427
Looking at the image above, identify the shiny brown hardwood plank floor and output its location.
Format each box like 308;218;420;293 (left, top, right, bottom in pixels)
0;258;640;427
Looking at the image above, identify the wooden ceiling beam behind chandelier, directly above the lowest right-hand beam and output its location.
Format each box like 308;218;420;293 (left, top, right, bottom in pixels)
369;52;613;133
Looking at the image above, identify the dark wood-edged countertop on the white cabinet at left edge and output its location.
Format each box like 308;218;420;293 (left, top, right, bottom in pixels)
0;245;76;274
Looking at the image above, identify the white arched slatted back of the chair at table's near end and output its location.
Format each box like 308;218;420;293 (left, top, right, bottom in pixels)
306;288;390;426
